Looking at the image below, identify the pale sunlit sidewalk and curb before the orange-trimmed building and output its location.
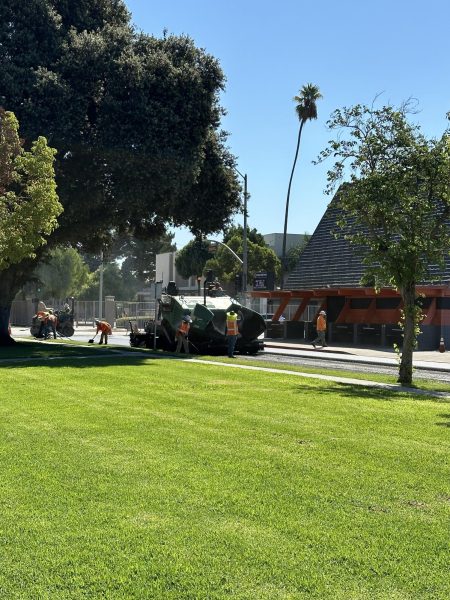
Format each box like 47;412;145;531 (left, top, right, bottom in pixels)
264;338;450;371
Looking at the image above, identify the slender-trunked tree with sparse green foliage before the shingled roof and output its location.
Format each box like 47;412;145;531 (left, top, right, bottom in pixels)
322;105;450;385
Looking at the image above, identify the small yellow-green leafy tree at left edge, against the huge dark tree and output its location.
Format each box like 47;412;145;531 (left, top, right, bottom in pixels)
0;109;62;344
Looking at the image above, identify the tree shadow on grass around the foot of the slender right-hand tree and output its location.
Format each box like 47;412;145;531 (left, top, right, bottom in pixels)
292;381;450;404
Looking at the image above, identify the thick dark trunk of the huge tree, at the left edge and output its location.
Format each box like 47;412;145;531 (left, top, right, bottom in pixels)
0;259;35;346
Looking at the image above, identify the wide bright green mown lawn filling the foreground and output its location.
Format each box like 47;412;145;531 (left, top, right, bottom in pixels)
0;344;450;600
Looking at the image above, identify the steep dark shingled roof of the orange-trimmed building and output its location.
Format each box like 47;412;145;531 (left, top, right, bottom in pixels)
284;198;450;290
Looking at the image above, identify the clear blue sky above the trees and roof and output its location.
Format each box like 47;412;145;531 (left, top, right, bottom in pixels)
125;0;450;247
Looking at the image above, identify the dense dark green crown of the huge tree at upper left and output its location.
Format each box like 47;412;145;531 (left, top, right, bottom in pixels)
0;0;240;344
